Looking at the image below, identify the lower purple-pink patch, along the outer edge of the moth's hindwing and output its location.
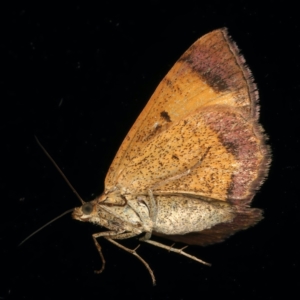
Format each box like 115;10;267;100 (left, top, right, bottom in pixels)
203;107;263;203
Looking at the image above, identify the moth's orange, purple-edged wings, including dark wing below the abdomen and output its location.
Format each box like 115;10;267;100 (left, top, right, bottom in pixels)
99;29;270;245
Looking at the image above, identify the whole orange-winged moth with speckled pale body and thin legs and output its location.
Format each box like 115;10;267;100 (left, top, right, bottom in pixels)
38;28;271;283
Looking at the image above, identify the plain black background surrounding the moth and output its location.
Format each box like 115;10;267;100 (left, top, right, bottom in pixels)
0;1;300;299
